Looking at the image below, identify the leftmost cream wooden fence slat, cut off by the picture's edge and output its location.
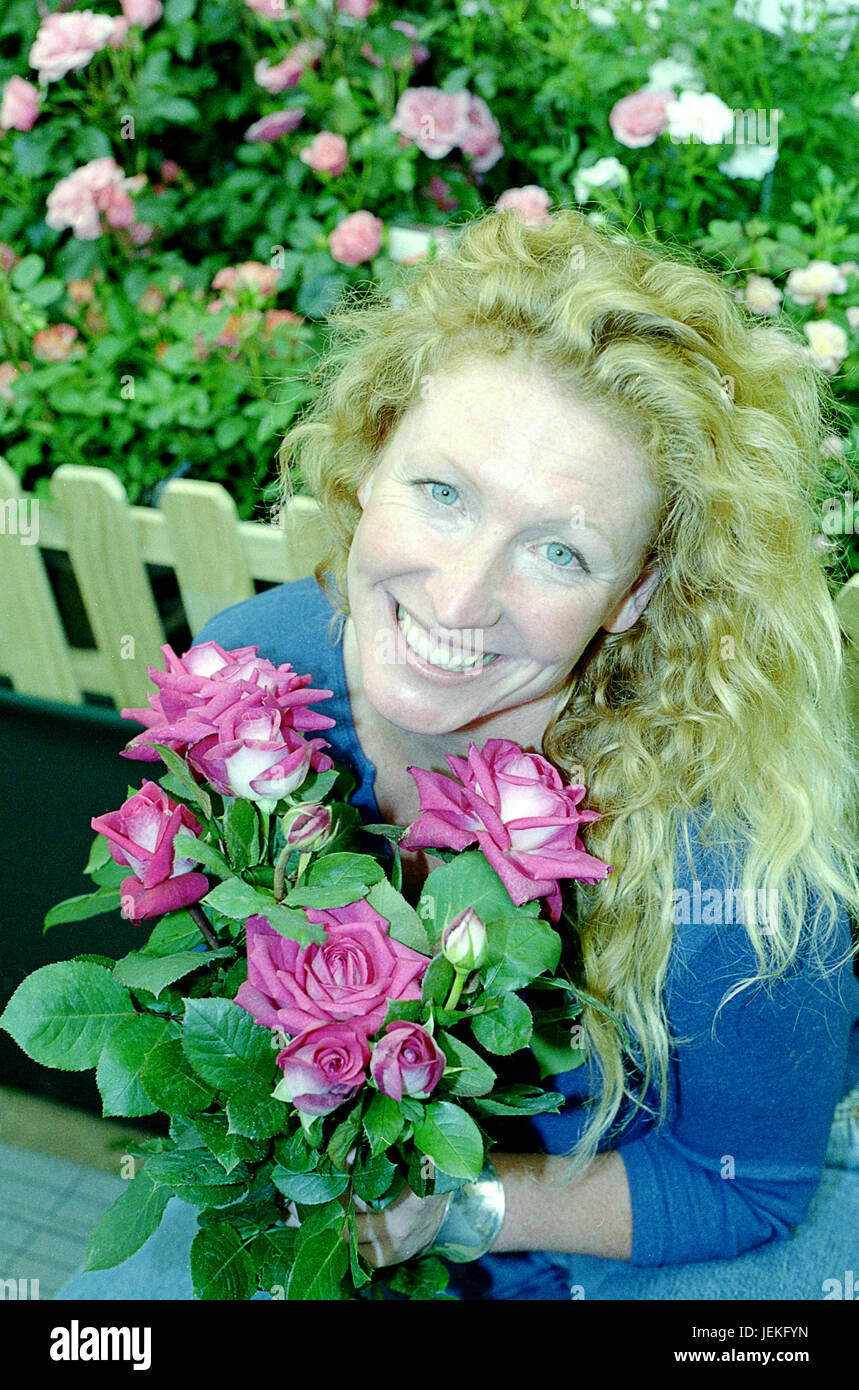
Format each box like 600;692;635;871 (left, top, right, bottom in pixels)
0;459;83;705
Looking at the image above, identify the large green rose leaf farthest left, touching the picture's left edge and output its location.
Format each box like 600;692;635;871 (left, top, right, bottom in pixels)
0;960;136;1072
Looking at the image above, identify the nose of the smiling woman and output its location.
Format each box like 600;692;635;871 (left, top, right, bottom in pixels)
424;532;503;630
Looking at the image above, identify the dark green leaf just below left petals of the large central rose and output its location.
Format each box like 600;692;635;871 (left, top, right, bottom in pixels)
182;999;274;1091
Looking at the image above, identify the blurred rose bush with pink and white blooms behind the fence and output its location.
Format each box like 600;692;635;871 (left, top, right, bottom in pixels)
0;0;859;553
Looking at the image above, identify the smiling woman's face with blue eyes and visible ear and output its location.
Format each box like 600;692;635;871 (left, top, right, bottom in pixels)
347;360;659;735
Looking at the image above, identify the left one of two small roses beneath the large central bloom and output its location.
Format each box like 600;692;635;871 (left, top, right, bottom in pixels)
274;1023;370;1115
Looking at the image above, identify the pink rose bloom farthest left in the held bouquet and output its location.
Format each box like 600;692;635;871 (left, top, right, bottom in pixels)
90;781;208;922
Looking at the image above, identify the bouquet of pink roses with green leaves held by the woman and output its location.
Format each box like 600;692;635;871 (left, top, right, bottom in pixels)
0;642;610;1300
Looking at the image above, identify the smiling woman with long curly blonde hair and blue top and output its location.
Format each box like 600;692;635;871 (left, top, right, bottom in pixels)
63;210;859;1298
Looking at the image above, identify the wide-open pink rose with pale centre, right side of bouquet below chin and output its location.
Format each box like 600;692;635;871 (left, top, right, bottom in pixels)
400;738;613;922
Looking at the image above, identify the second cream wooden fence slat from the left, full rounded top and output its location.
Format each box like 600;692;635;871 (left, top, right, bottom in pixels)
51;463;167;709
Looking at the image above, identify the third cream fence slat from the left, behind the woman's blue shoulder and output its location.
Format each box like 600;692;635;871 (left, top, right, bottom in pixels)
158;480;256;632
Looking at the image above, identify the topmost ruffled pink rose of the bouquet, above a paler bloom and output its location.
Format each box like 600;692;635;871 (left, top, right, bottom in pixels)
121;642;335;766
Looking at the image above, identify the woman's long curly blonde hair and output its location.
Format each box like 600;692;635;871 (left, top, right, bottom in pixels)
279;209;859;1176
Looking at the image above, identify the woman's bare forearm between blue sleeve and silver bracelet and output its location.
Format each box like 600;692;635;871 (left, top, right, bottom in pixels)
491;1151;632;1259
